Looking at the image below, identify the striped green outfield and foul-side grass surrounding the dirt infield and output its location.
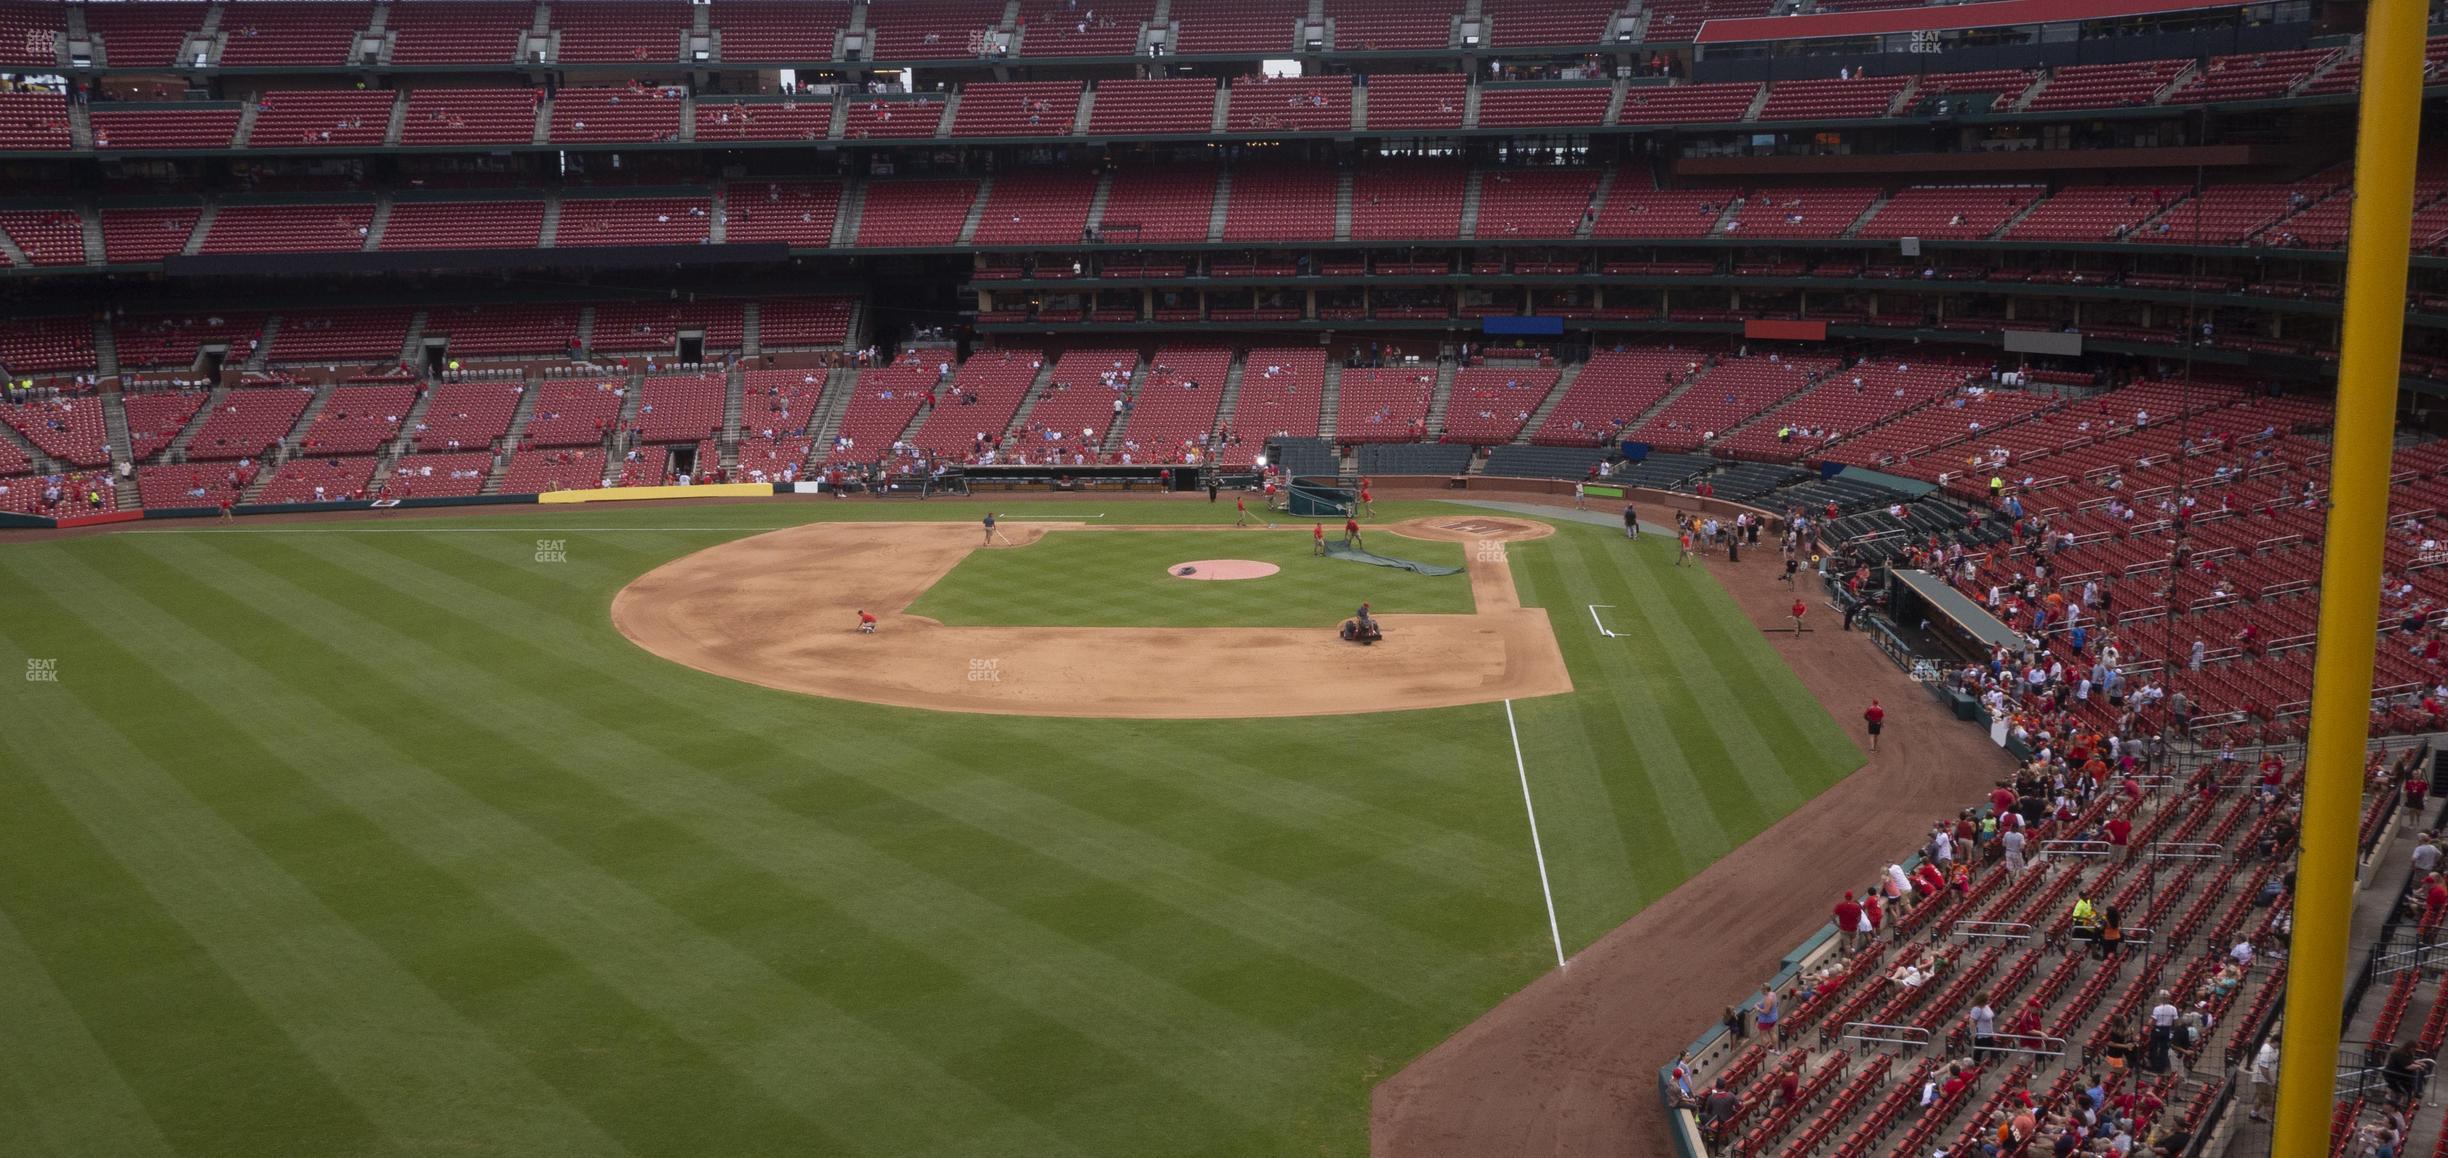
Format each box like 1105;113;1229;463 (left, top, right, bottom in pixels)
0;499;1860;1158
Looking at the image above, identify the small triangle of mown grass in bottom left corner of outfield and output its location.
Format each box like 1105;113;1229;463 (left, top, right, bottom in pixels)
0;881;171;1158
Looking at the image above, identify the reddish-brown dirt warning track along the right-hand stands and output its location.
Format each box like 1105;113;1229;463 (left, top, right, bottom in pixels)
1371;495;2012;1158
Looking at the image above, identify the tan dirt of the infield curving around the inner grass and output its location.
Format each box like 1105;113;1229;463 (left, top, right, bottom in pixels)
612;519;1572;720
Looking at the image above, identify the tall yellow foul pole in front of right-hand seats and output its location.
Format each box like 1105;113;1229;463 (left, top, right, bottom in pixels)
2272;0;2426;1158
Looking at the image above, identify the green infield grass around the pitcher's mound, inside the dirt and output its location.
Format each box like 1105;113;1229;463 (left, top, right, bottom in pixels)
911;524;1471;627
